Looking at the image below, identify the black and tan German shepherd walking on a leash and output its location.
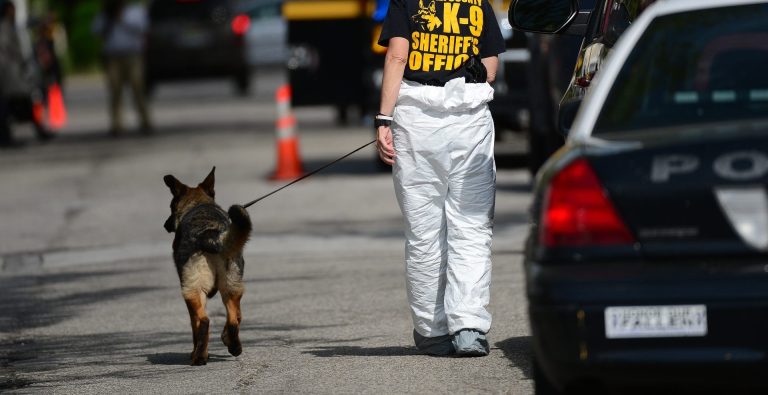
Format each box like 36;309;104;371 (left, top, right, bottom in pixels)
163;167;251;365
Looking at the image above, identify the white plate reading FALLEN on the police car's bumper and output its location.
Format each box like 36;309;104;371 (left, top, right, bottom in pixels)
605;305;707;339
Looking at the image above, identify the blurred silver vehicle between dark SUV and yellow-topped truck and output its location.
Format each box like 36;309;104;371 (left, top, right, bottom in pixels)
237;0;288;67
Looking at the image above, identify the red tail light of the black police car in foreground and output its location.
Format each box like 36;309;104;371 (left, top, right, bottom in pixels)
540;159;635;247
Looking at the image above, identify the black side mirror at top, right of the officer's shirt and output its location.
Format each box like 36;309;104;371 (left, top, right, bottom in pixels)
508;0;579;33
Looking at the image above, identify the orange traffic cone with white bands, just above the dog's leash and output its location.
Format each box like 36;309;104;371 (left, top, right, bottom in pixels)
270;84;304;180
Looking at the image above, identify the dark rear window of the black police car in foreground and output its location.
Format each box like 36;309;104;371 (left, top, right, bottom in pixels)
593;4;768;135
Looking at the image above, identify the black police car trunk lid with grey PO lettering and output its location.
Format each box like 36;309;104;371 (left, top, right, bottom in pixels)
589;133;768;258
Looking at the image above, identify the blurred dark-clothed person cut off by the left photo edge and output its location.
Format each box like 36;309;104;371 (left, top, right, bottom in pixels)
0;0;29;147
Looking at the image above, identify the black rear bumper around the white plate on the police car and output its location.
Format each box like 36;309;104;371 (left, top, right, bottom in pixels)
526;262;768;389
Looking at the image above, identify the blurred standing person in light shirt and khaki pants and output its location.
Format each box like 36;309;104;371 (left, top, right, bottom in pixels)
92;0;152;136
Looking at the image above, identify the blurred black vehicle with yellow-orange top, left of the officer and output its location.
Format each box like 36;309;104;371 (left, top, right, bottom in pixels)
283;0;389;124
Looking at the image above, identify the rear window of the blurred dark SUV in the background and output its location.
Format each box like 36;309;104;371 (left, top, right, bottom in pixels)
149;0;230;21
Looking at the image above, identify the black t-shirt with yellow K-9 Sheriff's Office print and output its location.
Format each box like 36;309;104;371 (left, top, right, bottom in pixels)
379;0;505;85
